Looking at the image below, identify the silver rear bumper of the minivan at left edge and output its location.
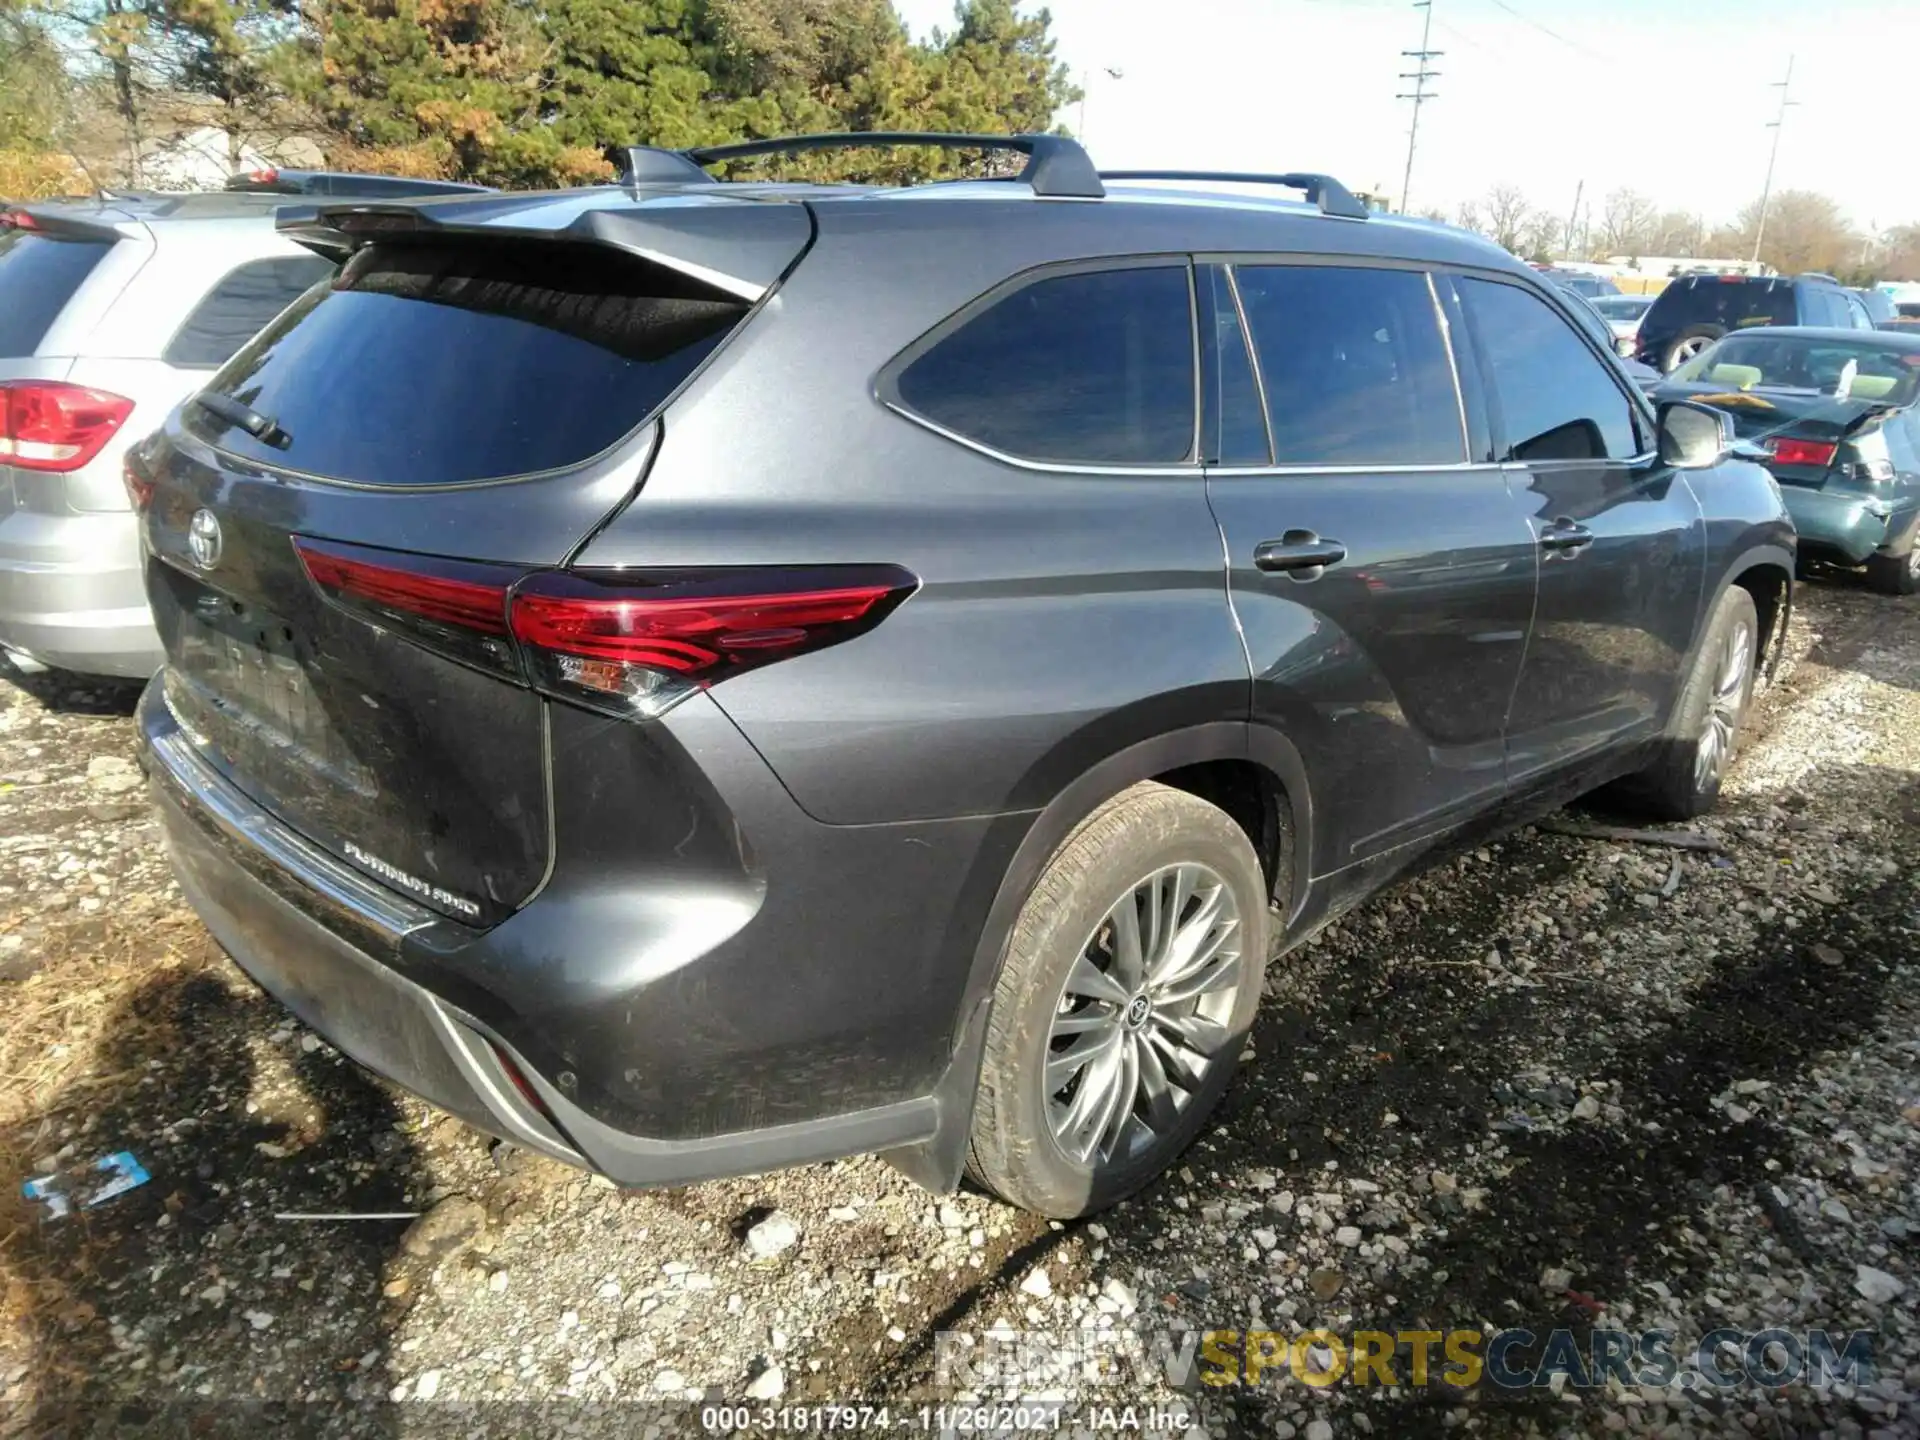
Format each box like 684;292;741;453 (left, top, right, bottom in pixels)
0;509;165;680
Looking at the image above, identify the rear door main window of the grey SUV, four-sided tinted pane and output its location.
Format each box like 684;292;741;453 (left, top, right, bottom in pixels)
1233;265;1467;465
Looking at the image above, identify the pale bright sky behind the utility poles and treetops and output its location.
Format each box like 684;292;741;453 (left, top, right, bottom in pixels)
895;0;1920;228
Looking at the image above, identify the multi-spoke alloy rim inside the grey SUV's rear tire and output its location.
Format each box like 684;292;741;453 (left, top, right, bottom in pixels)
1044;864;1246;1165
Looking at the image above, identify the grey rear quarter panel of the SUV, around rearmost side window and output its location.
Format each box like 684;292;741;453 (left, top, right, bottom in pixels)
576;202;1248;824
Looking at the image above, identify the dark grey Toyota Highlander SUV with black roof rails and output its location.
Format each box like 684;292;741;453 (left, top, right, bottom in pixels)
129;136;1793;1215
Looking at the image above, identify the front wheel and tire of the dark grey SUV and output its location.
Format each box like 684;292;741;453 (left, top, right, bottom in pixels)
1620;586;1761;820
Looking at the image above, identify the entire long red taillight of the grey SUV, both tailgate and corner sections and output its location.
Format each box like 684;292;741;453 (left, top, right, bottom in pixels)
294;538;920;718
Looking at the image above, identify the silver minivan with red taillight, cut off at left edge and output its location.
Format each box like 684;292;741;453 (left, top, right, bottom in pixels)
0;194;334;678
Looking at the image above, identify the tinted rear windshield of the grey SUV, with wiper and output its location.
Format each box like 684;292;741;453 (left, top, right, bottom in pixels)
184;242;747;486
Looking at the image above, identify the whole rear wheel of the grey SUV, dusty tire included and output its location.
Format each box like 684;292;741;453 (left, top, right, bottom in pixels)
968;783;1267;1219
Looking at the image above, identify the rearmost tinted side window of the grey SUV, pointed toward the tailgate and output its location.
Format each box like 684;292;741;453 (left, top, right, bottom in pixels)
895;265;1194;465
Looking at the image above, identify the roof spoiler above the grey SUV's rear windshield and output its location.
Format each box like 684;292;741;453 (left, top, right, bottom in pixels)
275;196;814;305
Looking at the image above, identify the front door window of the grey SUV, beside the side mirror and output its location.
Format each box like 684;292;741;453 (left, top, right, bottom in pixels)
1459;278;1640;463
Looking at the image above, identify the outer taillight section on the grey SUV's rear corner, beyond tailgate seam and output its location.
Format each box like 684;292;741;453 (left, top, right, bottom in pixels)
511;564;918;716
